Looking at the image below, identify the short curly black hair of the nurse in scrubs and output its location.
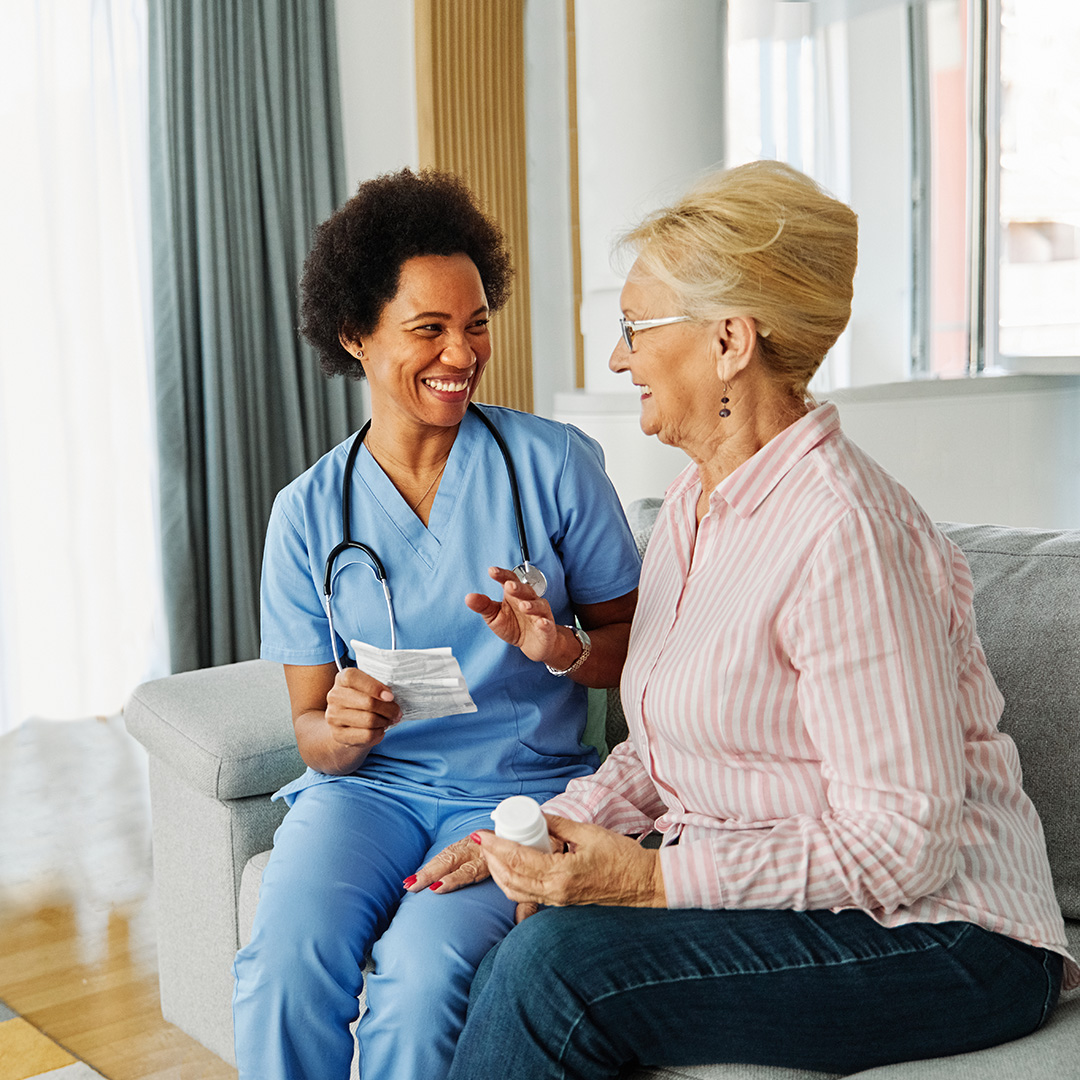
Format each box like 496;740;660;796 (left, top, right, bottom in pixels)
300;168;514;379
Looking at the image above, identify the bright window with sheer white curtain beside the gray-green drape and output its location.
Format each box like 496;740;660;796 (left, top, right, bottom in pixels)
0;0;165;733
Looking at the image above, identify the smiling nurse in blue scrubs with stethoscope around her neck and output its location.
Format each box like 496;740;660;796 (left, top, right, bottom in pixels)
233;170;639;1080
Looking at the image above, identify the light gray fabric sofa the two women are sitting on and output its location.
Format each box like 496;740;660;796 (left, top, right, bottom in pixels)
124;500;1080;1080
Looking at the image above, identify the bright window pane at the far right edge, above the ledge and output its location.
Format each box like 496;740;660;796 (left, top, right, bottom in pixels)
999;0;1080;356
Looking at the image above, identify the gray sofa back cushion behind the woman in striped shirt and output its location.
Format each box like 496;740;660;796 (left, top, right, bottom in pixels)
607;499;1080;918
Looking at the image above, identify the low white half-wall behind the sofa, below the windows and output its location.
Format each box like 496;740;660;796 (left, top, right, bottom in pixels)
556;375;1080;529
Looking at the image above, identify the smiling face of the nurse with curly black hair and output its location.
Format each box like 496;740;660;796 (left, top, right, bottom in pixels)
352;255;491;428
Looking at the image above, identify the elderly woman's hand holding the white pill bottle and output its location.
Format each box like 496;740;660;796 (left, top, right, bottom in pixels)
474;814;667;921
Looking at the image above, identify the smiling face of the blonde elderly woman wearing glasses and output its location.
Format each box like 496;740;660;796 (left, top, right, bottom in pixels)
608;262;718;448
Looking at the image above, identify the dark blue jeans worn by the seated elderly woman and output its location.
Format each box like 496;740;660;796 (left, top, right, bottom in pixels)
450;907;1062;1080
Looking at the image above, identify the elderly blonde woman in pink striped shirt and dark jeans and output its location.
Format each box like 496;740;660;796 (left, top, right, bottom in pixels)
429;162;1080;1080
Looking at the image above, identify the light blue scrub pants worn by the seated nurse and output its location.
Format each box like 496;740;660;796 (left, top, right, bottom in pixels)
232;778;555;1080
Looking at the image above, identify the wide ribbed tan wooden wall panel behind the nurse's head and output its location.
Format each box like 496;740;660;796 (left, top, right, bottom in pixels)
414;0;532;411
